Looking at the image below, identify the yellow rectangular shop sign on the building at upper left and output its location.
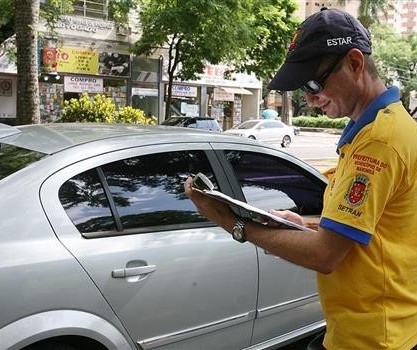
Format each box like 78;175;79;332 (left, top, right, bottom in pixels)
57;47;98;74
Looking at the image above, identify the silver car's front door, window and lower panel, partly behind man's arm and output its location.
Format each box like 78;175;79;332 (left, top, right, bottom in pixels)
210;145;326;343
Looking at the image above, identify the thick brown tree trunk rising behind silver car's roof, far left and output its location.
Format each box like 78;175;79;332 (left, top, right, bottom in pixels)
15;0;40;125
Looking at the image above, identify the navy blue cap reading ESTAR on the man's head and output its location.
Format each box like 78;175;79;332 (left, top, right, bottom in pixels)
268;8;372;91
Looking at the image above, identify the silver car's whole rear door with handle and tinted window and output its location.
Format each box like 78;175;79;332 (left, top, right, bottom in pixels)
41;143;258;350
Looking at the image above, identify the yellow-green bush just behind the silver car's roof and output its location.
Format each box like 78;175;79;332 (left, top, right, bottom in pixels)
60;93;156;125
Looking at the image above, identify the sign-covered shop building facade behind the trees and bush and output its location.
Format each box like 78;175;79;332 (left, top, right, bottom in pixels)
0;0;262;128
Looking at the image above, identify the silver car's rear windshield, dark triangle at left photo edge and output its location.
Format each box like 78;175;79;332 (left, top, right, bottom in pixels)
0;143;46;180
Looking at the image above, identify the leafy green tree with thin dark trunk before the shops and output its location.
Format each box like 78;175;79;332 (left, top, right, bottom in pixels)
133;0;255;118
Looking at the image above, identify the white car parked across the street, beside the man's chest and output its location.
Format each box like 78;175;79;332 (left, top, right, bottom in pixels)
225;119;296;147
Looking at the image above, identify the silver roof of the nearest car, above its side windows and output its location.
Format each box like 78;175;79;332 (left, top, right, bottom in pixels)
0;123;240;154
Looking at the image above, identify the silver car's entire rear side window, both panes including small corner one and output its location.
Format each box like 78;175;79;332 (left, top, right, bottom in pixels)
59;151;217;236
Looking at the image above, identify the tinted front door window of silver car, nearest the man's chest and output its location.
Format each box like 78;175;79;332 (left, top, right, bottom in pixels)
225;151;326;215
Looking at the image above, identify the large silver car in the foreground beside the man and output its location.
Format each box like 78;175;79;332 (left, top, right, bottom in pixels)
0;123;326;350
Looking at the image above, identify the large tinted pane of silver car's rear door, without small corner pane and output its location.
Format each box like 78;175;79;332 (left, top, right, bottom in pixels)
102;151;212;229
